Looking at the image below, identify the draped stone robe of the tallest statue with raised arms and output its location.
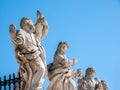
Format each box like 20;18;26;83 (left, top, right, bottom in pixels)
12;25;47;90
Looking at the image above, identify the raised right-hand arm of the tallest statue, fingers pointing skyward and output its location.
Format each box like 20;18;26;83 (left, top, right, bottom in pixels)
34;11;48;42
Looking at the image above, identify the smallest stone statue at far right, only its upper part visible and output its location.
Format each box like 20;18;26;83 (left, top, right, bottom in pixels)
78;67;108;90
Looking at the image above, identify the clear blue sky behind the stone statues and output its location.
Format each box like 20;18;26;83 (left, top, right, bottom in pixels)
0;0;120;90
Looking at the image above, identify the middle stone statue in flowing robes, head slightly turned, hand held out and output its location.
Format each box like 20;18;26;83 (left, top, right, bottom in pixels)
48;42;77;90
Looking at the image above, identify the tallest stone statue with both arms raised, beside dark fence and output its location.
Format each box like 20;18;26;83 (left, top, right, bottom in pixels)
9;11;48;90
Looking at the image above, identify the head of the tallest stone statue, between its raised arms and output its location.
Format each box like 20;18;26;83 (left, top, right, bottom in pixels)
20;17;35;31
